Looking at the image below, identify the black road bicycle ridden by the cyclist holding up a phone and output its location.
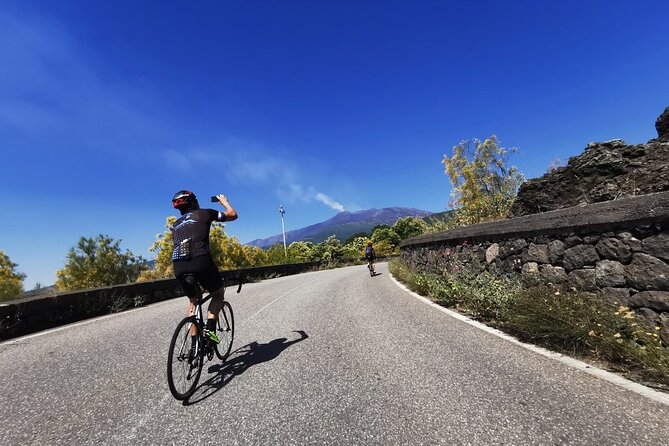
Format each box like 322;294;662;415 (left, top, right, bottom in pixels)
167;275;243;400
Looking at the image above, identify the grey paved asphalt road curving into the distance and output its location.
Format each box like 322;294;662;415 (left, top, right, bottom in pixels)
0;264;669;446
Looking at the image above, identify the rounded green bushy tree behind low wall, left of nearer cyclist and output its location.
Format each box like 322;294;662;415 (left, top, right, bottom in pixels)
56;234;147;291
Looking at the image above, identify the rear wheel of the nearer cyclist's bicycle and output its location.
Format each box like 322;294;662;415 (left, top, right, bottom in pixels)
167;316;204;400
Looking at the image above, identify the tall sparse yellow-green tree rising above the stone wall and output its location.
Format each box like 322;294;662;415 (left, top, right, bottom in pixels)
442;135;524;226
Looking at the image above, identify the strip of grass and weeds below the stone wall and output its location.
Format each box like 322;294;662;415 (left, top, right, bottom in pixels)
390;259;669;390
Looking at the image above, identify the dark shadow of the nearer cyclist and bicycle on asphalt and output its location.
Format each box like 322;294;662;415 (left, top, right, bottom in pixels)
184;330;309;405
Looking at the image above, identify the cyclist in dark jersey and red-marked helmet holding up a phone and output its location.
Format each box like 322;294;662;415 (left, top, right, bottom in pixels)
170;190;237;356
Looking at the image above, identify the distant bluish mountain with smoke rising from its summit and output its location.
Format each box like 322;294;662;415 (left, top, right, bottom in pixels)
247;207;432;248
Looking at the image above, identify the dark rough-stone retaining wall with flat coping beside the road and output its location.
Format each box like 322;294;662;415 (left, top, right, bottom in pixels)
400;192;669;334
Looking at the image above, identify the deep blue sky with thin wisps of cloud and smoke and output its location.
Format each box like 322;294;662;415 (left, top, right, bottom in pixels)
0;0;669;289
